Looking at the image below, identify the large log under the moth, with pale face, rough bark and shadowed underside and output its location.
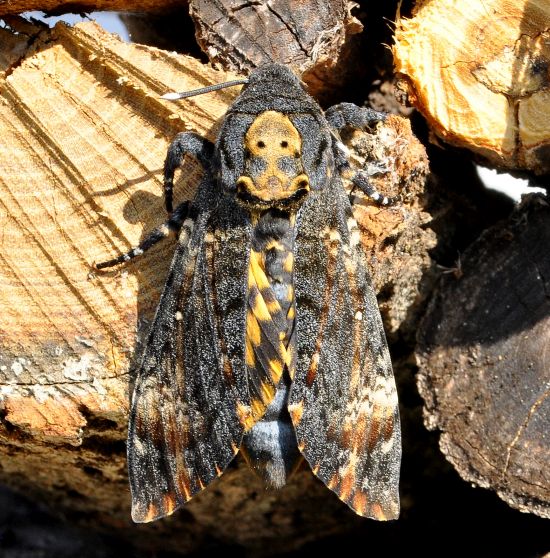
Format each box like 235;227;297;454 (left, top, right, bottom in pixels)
0;19;433;554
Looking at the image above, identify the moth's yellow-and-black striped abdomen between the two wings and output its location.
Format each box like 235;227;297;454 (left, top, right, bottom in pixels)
243;210;299;488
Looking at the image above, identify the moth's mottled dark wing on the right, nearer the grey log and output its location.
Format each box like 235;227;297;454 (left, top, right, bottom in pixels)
289;177;401;519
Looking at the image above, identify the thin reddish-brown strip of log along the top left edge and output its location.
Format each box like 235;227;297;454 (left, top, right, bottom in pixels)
0;0;185;16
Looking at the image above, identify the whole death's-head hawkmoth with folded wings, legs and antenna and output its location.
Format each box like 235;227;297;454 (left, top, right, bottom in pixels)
96;64;401;522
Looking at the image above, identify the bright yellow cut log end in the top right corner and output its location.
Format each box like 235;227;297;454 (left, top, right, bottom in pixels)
393;0;550;174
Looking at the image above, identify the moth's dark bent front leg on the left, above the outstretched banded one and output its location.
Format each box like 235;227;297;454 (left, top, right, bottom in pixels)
164;132;214;214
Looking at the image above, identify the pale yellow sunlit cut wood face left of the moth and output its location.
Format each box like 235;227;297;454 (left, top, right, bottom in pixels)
0;19;239;445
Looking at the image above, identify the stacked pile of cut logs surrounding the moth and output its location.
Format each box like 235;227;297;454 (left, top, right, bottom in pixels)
0;0;550;558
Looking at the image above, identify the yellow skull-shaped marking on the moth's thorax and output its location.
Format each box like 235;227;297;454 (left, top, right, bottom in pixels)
237;110;310;209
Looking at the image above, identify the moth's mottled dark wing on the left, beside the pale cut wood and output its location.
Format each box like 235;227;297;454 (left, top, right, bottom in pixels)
128;184;251;522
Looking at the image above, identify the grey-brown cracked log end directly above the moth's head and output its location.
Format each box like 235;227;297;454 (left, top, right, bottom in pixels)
189;0;363;103
